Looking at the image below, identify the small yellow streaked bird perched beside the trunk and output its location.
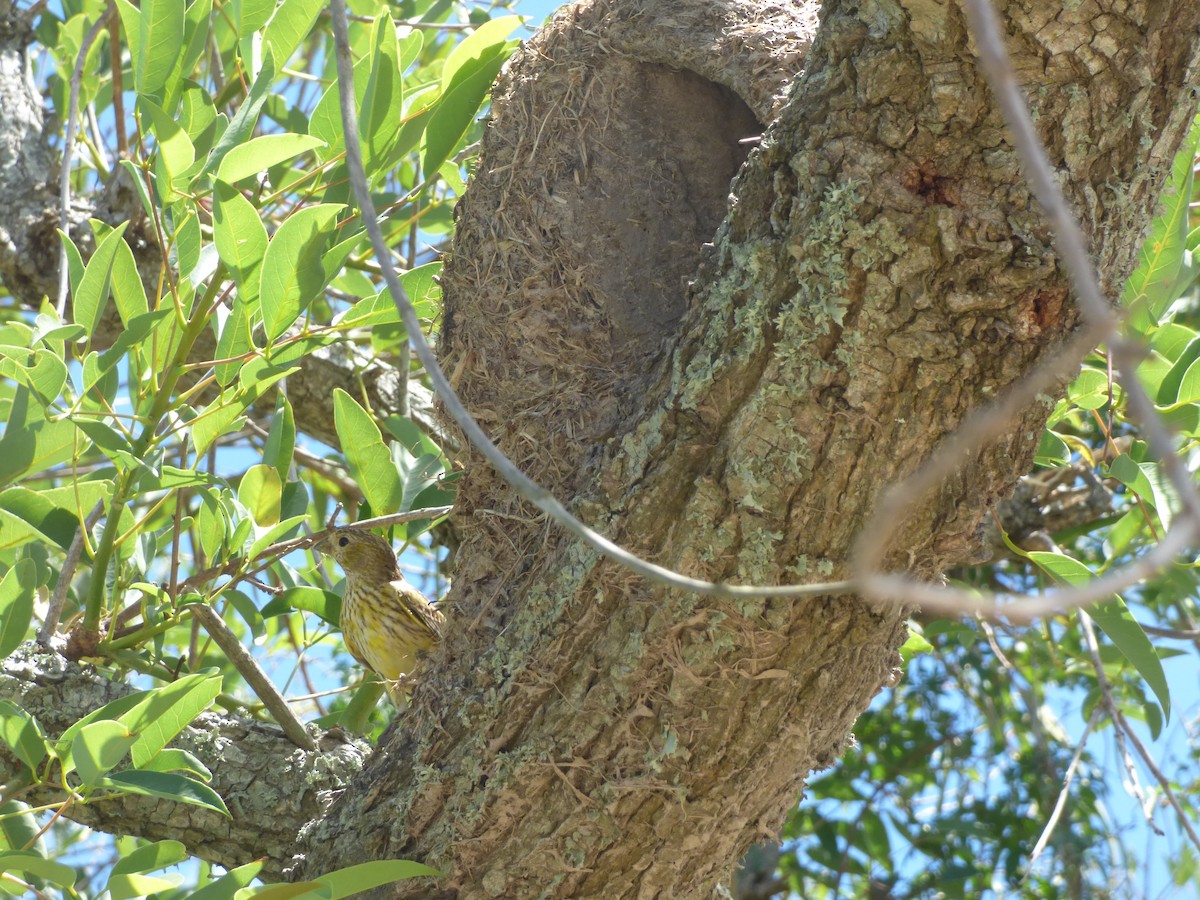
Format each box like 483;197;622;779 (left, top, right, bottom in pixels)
314;528;445;709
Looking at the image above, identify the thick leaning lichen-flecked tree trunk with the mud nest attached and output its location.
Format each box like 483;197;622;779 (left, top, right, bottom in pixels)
297;0;1200;898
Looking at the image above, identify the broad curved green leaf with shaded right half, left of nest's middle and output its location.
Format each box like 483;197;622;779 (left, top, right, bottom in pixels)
258;203;344;341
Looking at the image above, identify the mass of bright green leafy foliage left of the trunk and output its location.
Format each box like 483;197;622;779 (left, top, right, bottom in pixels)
0;0;521;898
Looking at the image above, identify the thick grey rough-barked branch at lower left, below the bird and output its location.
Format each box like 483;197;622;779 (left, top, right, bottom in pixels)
0;644;370;880
